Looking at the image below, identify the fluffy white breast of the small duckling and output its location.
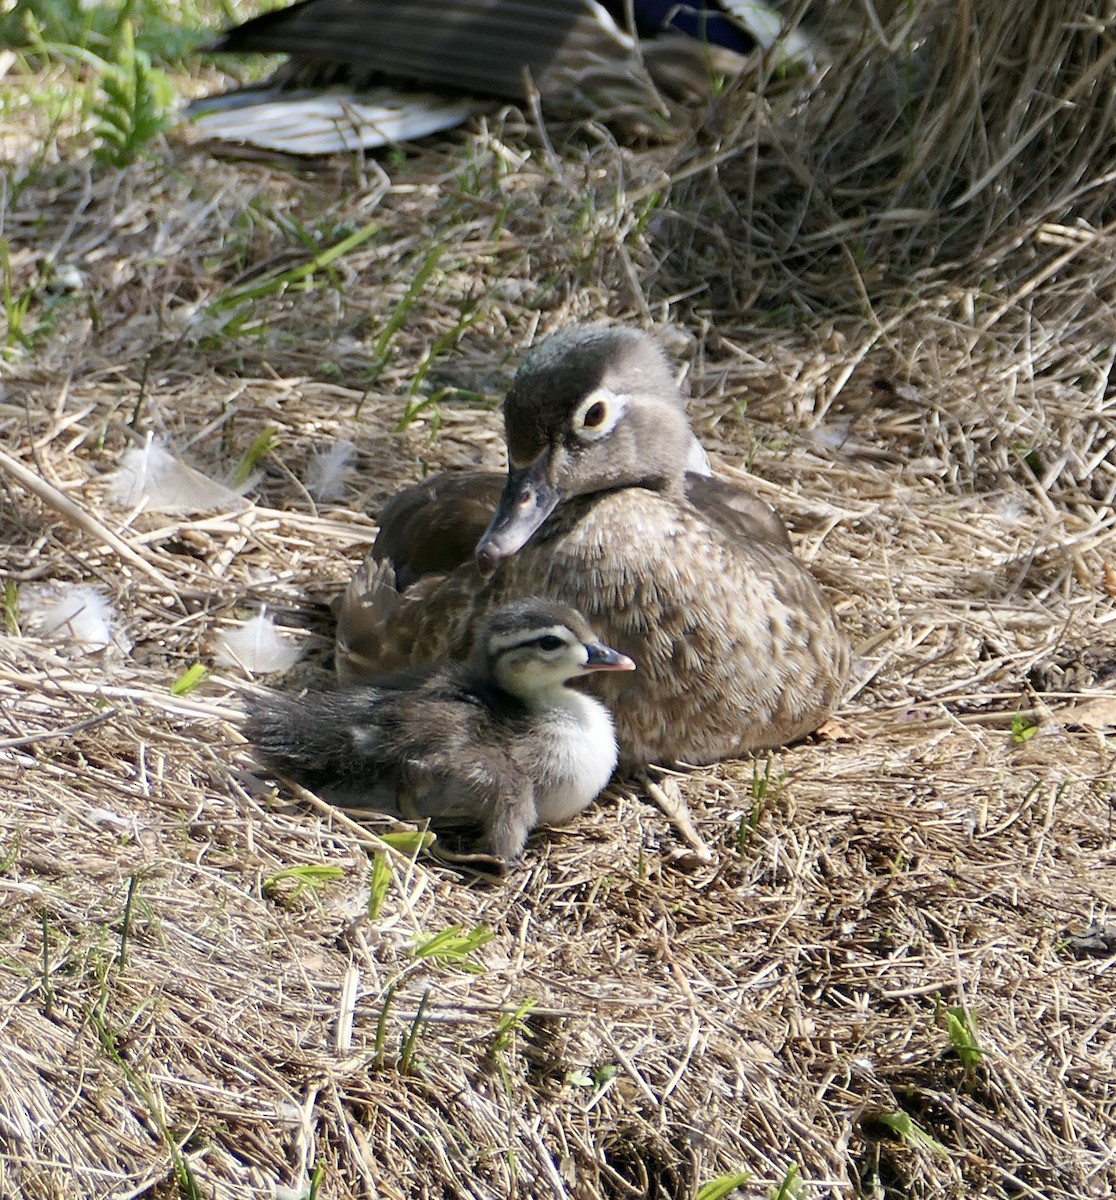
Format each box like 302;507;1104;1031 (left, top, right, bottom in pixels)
528;689;618;824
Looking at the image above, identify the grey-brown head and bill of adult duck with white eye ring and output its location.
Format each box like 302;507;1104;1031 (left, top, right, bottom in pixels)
476;324;703;575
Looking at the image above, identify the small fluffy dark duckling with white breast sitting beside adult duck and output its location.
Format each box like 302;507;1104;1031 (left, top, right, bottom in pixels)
246;595;635;860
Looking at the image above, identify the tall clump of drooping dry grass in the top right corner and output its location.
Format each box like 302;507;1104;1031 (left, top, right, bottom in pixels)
662;0;1116;313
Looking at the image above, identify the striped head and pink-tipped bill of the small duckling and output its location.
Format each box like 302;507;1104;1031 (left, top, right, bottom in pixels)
473;598;636;704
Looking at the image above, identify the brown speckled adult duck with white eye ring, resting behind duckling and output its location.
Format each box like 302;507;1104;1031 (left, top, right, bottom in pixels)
336;324;850;768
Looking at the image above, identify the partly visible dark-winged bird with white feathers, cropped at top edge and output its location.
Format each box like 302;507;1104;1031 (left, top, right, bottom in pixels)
191;0;815;154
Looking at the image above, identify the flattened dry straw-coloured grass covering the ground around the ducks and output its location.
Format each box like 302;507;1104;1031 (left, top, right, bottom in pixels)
0;0;1116;1200
